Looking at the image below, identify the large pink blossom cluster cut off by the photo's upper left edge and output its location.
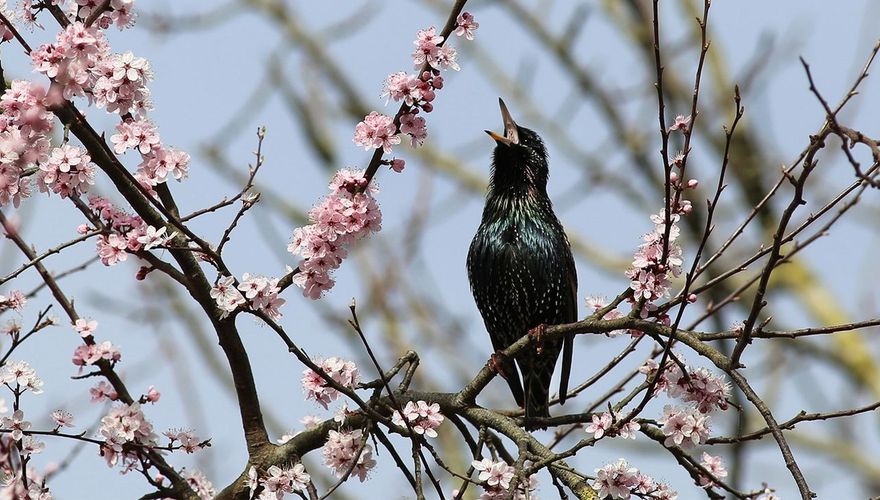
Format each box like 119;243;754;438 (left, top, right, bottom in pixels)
0;80;54;207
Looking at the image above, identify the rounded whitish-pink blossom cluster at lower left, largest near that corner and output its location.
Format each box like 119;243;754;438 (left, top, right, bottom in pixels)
98;403;158;467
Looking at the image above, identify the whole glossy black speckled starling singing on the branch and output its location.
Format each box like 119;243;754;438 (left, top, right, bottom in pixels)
467;99;577;428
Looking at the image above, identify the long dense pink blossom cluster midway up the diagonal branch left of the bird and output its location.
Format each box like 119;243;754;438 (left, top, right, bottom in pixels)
287;169;382;299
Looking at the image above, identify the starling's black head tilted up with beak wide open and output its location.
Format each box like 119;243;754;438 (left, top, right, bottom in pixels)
486;98;548;194
